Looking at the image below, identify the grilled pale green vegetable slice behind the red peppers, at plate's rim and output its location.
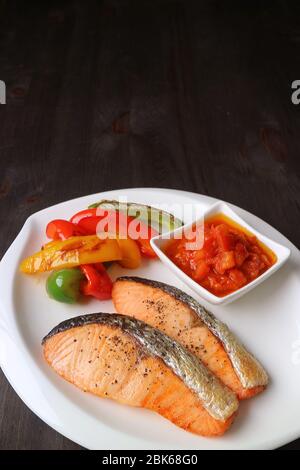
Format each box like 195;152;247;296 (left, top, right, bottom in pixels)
85;199;183;233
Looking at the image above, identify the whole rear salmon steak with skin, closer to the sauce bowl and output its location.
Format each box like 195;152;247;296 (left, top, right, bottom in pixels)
112;277;268;399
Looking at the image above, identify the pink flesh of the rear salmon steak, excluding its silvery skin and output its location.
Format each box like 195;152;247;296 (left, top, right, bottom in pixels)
112;277;266;400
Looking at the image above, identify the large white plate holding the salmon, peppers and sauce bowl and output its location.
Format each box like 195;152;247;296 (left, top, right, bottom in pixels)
0;189;300;449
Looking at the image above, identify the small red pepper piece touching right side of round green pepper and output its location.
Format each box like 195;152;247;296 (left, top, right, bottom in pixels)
80;263;113;300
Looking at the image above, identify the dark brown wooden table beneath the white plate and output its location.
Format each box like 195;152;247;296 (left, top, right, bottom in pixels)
0;0;300;449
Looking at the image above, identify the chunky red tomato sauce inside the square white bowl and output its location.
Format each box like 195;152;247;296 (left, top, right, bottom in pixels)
165;214;276;297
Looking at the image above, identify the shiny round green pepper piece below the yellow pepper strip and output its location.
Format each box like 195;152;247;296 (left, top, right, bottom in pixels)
46;269;84;304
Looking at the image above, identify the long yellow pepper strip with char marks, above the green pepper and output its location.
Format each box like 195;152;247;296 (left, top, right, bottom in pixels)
20;235;122;274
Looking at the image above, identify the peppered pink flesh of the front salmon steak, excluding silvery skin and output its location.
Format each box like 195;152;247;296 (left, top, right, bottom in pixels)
43;314;235;436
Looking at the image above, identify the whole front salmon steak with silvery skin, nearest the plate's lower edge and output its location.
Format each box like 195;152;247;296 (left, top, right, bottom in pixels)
42;313;238;436
